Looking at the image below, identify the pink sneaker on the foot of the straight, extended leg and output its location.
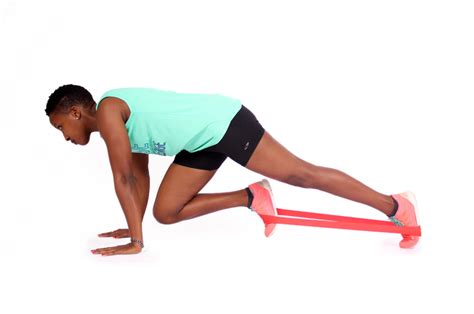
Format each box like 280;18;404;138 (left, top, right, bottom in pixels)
389;191;419;249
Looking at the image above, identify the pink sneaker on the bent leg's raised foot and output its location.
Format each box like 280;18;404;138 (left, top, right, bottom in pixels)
248;179;276;237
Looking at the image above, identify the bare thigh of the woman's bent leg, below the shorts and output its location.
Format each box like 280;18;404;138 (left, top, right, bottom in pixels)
153;163;217;223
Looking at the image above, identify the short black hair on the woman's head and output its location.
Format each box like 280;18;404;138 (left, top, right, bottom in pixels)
45;84;95;116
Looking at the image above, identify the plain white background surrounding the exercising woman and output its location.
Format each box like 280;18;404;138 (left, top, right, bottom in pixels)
0;0;474;313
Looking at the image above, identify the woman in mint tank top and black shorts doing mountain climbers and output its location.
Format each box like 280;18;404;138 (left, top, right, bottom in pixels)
45;84;418;255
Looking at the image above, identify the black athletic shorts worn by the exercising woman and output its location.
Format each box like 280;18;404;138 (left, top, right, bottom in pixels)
173;105;265;170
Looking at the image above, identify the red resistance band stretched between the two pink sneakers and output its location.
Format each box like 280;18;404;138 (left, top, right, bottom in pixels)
259;208;421;236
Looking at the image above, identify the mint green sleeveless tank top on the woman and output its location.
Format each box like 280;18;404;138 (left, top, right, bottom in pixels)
96;87;242;156
